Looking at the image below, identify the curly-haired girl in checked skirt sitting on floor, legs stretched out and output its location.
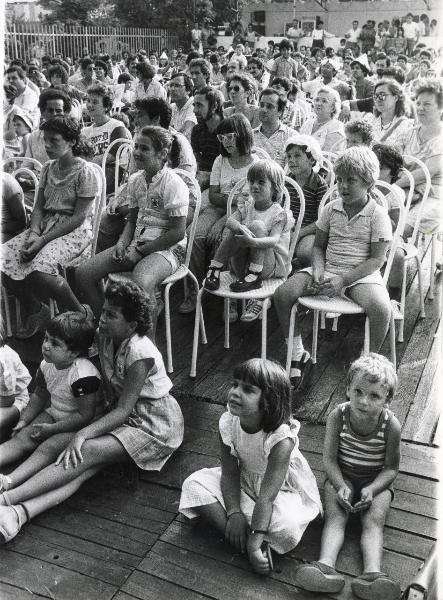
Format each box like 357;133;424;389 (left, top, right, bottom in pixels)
0;282;184;543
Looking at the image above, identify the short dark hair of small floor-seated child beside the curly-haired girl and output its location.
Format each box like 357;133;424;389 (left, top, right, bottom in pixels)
46;310;95;356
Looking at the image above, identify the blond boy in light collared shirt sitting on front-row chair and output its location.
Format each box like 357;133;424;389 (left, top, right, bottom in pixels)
274;146;392;387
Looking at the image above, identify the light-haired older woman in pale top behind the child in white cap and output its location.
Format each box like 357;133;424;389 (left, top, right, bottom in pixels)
300;86;346;151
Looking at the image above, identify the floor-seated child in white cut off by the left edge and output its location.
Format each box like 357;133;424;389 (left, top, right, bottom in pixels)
0;315;31;441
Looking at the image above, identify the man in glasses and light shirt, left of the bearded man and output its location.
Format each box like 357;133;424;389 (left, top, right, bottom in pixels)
168;73;197;141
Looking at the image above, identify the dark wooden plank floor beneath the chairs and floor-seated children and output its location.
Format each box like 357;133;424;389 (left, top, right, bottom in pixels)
0;237;443;600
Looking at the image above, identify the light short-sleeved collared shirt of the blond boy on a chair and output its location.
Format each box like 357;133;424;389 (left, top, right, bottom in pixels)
316;198;392;275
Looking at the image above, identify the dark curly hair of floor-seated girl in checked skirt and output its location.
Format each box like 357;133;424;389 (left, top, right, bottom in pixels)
105;281;152;335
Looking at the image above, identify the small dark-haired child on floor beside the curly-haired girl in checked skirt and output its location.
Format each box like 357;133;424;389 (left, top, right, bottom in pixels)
0;312;100;492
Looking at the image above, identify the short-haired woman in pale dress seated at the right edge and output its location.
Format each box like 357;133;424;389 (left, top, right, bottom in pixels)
395;81;443;239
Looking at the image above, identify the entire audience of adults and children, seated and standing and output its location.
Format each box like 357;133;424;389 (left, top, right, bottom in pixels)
0;16;443;600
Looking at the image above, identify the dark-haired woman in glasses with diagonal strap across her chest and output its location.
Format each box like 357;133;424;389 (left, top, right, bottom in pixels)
369;79;413;152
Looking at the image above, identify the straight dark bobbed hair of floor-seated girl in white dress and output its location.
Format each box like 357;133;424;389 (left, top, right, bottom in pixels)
233;358;291;433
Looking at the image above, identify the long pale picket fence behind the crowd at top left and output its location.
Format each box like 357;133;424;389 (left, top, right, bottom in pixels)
5;22;178;59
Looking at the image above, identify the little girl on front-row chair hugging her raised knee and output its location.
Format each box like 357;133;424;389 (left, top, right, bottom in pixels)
204;160;294;321
